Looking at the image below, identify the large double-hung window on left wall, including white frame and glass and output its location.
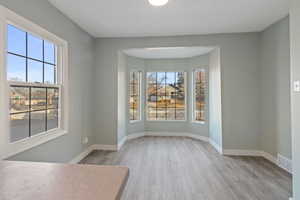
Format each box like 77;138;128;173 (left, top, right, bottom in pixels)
0;7;68;159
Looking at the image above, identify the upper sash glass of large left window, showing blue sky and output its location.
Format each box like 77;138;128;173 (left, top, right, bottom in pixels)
7;25;56;84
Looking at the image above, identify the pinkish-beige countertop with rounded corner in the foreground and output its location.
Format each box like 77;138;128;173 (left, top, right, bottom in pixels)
0;161;129;200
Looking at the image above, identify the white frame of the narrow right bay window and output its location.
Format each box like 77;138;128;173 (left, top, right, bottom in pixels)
191;67;208;124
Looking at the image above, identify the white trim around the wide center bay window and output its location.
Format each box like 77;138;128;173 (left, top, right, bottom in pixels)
145;70;188;122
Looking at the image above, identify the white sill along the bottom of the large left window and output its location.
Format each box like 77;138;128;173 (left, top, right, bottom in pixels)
3;129;68;159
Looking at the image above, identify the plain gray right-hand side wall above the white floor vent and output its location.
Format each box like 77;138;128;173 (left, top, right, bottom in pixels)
260;17;292;159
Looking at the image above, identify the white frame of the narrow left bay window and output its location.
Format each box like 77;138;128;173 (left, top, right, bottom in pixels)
128;70;143;124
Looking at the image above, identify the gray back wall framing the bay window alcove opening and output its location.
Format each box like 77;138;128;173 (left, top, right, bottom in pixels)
94;33;260;150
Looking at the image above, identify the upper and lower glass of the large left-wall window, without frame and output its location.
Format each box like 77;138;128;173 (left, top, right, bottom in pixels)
6;25;59;142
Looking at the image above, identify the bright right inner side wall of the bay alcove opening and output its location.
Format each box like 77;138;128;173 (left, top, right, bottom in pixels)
209;48;223;148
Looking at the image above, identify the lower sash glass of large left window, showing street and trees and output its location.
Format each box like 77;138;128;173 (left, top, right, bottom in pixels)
10;86;59;142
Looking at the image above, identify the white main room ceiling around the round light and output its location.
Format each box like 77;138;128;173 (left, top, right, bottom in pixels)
49;0;289;37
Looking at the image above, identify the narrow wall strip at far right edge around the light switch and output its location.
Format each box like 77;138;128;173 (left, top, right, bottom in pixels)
290;0;300;200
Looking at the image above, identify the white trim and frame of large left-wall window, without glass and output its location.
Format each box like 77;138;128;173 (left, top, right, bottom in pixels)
0;6;69;160
